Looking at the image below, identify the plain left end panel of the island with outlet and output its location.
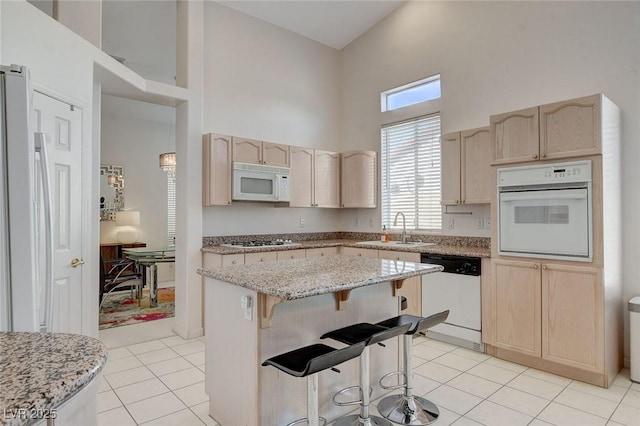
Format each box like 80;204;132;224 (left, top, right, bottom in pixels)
204;278;261;426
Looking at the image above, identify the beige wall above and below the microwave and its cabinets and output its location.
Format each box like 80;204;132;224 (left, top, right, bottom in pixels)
203;2;341;235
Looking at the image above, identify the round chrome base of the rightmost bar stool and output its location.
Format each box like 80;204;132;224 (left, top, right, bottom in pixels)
378;395;440;426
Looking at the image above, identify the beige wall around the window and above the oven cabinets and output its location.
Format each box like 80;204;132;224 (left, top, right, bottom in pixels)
341;1;640;362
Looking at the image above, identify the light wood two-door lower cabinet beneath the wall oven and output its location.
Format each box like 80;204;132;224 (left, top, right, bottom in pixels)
482;259;621;387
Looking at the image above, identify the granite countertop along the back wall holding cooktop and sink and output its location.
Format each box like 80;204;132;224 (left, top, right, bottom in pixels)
202;239;491;257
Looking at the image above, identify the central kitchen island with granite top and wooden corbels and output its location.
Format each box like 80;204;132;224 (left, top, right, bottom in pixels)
198;255;442;426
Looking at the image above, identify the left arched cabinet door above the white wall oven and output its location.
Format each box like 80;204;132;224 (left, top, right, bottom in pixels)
491;107;540;164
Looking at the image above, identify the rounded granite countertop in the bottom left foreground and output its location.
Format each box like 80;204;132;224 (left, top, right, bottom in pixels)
0;332;107;426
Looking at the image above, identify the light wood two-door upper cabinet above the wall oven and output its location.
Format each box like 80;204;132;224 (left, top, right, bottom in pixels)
491;94;603;164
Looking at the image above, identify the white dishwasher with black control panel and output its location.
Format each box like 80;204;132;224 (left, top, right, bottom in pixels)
420;253;484;352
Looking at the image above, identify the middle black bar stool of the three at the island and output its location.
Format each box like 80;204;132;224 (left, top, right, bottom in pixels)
320;323;411;426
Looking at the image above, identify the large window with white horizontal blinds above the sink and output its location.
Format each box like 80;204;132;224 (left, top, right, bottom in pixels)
381;114;442;230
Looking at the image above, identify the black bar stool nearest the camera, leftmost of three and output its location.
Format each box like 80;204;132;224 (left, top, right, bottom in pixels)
262;343;365;426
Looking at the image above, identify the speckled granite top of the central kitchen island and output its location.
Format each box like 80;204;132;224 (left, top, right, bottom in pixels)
198;255;443;300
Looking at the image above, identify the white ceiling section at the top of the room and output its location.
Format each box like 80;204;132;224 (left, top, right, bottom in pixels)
218;0;405;50
